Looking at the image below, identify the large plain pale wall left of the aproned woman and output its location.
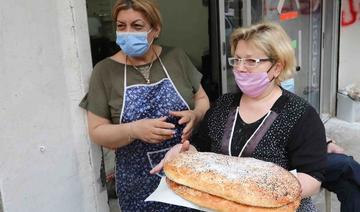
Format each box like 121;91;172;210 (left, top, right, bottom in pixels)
0;0;108;212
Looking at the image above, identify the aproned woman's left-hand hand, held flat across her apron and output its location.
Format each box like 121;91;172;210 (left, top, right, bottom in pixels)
129;117;175;144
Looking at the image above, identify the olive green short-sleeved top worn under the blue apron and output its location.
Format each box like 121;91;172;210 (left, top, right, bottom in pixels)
80;47;202;124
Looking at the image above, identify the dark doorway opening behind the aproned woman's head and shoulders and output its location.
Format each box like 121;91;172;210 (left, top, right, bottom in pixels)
86;0;220;101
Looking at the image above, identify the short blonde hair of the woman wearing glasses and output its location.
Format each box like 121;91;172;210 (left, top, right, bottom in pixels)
230;22;296;83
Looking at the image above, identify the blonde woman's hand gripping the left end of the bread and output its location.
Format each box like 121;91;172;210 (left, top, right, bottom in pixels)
150;140;196;174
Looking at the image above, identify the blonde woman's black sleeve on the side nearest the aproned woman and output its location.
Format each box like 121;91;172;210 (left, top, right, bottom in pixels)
190;109;212;152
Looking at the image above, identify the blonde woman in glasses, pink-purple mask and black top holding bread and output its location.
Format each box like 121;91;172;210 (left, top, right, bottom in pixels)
152;23;326;211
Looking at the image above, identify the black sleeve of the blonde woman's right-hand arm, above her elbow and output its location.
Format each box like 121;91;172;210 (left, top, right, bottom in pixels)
288;106;327;182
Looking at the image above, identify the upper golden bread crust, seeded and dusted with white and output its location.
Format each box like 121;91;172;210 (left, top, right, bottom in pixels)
164;152;301;208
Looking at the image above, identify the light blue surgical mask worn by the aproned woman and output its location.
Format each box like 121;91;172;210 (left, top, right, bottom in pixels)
116;29;151;57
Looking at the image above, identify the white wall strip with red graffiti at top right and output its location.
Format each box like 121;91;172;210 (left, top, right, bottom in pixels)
339;0;360;89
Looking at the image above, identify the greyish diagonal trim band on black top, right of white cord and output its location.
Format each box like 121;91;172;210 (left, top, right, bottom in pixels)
241;111;278;157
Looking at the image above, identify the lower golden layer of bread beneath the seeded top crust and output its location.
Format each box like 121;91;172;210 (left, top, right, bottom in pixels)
166;178;300;212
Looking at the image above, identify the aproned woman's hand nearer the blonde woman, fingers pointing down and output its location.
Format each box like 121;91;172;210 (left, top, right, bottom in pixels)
170;110;197;141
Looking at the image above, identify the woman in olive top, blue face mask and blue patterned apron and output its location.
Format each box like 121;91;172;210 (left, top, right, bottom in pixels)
81;0;209;211
